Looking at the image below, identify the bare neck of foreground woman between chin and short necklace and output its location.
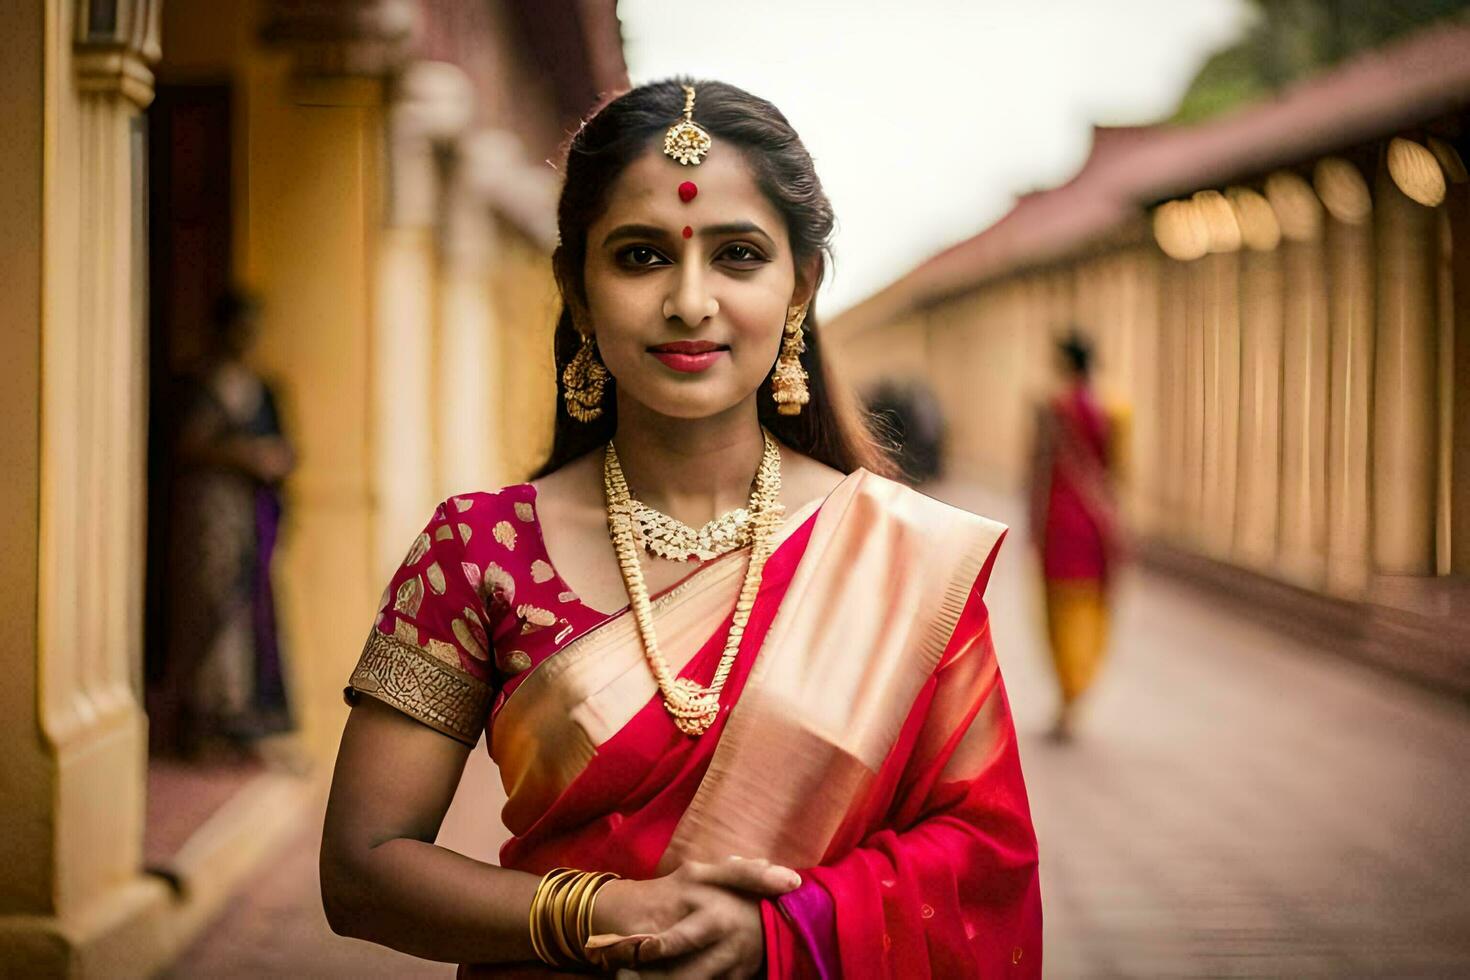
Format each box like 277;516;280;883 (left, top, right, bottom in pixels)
613;397;764;527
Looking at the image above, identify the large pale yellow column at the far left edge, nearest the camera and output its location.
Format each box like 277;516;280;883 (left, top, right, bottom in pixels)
0;0;168;976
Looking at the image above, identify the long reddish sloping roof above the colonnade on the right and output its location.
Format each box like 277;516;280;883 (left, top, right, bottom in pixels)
832;24;1470;332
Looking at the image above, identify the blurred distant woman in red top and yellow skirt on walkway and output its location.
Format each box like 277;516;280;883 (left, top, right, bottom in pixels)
1030;331;1122;741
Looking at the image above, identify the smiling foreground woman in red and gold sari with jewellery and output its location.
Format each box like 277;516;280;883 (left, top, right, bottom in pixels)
322;81;1041;977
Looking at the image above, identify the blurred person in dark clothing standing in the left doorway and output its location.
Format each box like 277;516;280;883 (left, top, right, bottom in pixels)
166;291;294;755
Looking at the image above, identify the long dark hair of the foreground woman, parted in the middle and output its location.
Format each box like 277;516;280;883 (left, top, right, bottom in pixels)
535;78;894;476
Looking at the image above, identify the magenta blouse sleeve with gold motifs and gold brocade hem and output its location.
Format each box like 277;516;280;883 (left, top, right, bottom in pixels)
344;501;495;745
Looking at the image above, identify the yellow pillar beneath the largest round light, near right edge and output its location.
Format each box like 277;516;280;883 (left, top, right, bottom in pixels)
1373;157;1439;574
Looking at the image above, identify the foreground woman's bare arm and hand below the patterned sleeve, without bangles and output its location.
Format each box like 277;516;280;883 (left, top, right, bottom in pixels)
320;698;800;964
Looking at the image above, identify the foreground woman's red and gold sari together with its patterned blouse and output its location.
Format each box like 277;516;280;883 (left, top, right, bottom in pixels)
350;470;1041;977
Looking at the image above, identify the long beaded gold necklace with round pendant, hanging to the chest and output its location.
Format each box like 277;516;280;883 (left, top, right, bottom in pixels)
603;429;784;735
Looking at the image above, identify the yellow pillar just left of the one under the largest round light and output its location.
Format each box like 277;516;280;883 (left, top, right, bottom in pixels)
1314;157;1374;597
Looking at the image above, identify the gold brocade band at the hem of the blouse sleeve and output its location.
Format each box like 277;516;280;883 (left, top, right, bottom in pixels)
343;629;492;748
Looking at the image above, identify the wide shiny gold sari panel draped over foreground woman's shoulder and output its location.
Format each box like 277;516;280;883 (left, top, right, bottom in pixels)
660;470;1005;870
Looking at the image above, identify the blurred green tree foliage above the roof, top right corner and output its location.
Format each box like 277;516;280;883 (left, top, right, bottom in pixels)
1173;0;1470;123
